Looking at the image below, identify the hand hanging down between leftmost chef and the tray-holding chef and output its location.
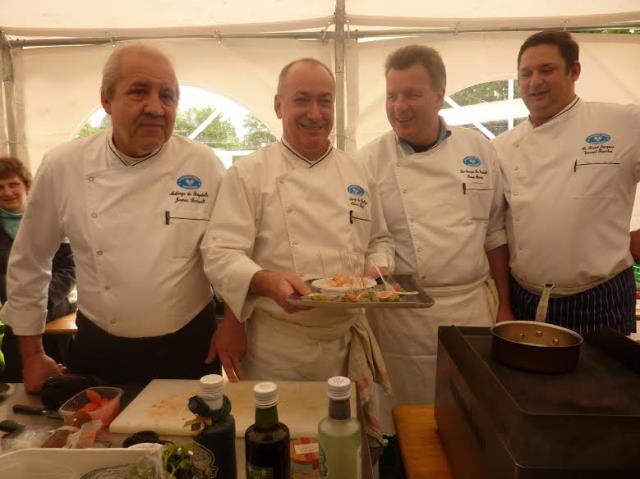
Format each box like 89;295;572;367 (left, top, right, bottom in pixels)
204;307;247;383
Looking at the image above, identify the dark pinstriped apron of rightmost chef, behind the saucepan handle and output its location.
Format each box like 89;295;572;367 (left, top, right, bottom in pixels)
509;268;636;335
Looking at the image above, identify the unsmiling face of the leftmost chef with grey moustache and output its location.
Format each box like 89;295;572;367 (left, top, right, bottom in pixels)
102;51;178;158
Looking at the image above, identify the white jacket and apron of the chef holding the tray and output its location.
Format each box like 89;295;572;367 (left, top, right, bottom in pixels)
202;142;393;380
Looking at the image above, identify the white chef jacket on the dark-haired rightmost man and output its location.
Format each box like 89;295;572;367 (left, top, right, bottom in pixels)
494;98;640;292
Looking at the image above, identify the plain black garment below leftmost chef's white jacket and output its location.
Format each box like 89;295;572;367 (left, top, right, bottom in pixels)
69;302;220;384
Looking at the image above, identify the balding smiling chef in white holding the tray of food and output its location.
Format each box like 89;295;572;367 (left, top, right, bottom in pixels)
202;59;393;394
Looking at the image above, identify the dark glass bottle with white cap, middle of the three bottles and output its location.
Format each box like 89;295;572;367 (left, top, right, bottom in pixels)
244;382;290;479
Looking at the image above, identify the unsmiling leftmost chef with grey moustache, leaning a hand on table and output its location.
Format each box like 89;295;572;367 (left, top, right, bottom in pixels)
1;44;224;390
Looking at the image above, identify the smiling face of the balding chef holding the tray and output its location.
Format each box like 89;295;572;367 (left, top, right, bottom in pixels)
274;61;335;160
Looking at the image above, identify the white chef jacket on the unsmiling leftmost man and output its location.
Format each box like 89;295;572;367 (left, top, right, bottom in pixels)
0;131;224;337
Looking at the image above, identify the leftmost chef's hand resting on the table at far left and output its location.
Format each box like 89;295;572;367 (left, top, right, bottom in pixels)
18;336;67;393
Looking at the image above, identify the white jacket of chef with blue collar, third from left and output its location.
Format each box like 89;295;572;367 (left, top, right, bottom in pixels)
358;124;506;287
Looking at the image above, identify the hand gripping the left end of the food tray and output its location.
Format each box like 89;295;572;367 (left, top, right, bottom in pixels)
249;270;311;313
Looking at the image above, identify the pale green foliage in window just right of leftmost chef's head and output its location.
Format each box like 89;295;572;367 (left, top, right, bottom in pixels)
174;106;240;150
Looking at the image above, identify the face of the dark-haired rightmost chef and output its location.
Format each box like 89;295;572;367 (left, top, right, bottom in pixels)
518;44;580;125
